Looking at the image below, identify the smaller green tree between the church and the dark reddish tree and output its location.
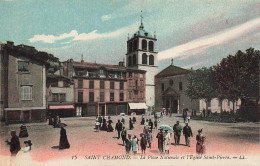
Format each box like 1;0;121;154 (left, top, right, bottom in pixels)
185;67;216;111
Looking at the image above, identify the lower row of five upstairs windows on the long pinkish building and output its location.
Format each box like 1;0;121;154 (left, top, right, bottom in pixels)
78;92;124;102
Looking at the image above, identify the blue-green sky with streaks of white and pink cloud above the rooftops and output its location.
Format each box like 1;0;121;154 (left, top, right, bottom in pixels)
0;0;260;71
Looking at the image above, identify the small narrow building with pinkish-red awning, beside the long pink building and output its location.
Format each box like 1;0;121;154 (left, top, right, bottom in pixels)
46;62;73;117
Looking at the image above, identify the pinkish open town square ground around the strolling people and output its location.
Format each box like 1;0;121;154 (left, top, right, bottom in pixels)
0;115;260;165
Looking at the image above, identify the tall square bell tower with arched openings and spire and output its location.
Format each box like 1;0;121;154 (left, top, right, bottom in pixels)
126;12;158;109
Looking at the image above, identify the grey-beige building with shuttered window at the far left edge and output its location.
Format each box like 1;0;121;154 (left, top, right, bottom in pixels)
0;42;49;123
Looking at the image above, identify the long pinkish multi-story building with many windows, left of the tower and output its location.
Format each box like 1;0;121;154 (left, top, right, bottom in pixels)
64;60;145;116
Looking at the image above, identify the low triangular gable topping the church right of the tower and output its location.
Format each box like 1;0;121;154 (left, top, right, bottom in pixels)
155;65;191;78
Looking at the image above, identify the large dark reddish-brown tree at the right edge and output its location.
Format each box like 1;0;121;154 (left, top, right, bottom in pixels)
215;48;260;108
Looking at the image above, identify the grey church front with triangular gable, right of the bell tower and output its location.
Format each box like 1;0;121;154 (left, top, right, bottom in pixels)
155;63;199;113
